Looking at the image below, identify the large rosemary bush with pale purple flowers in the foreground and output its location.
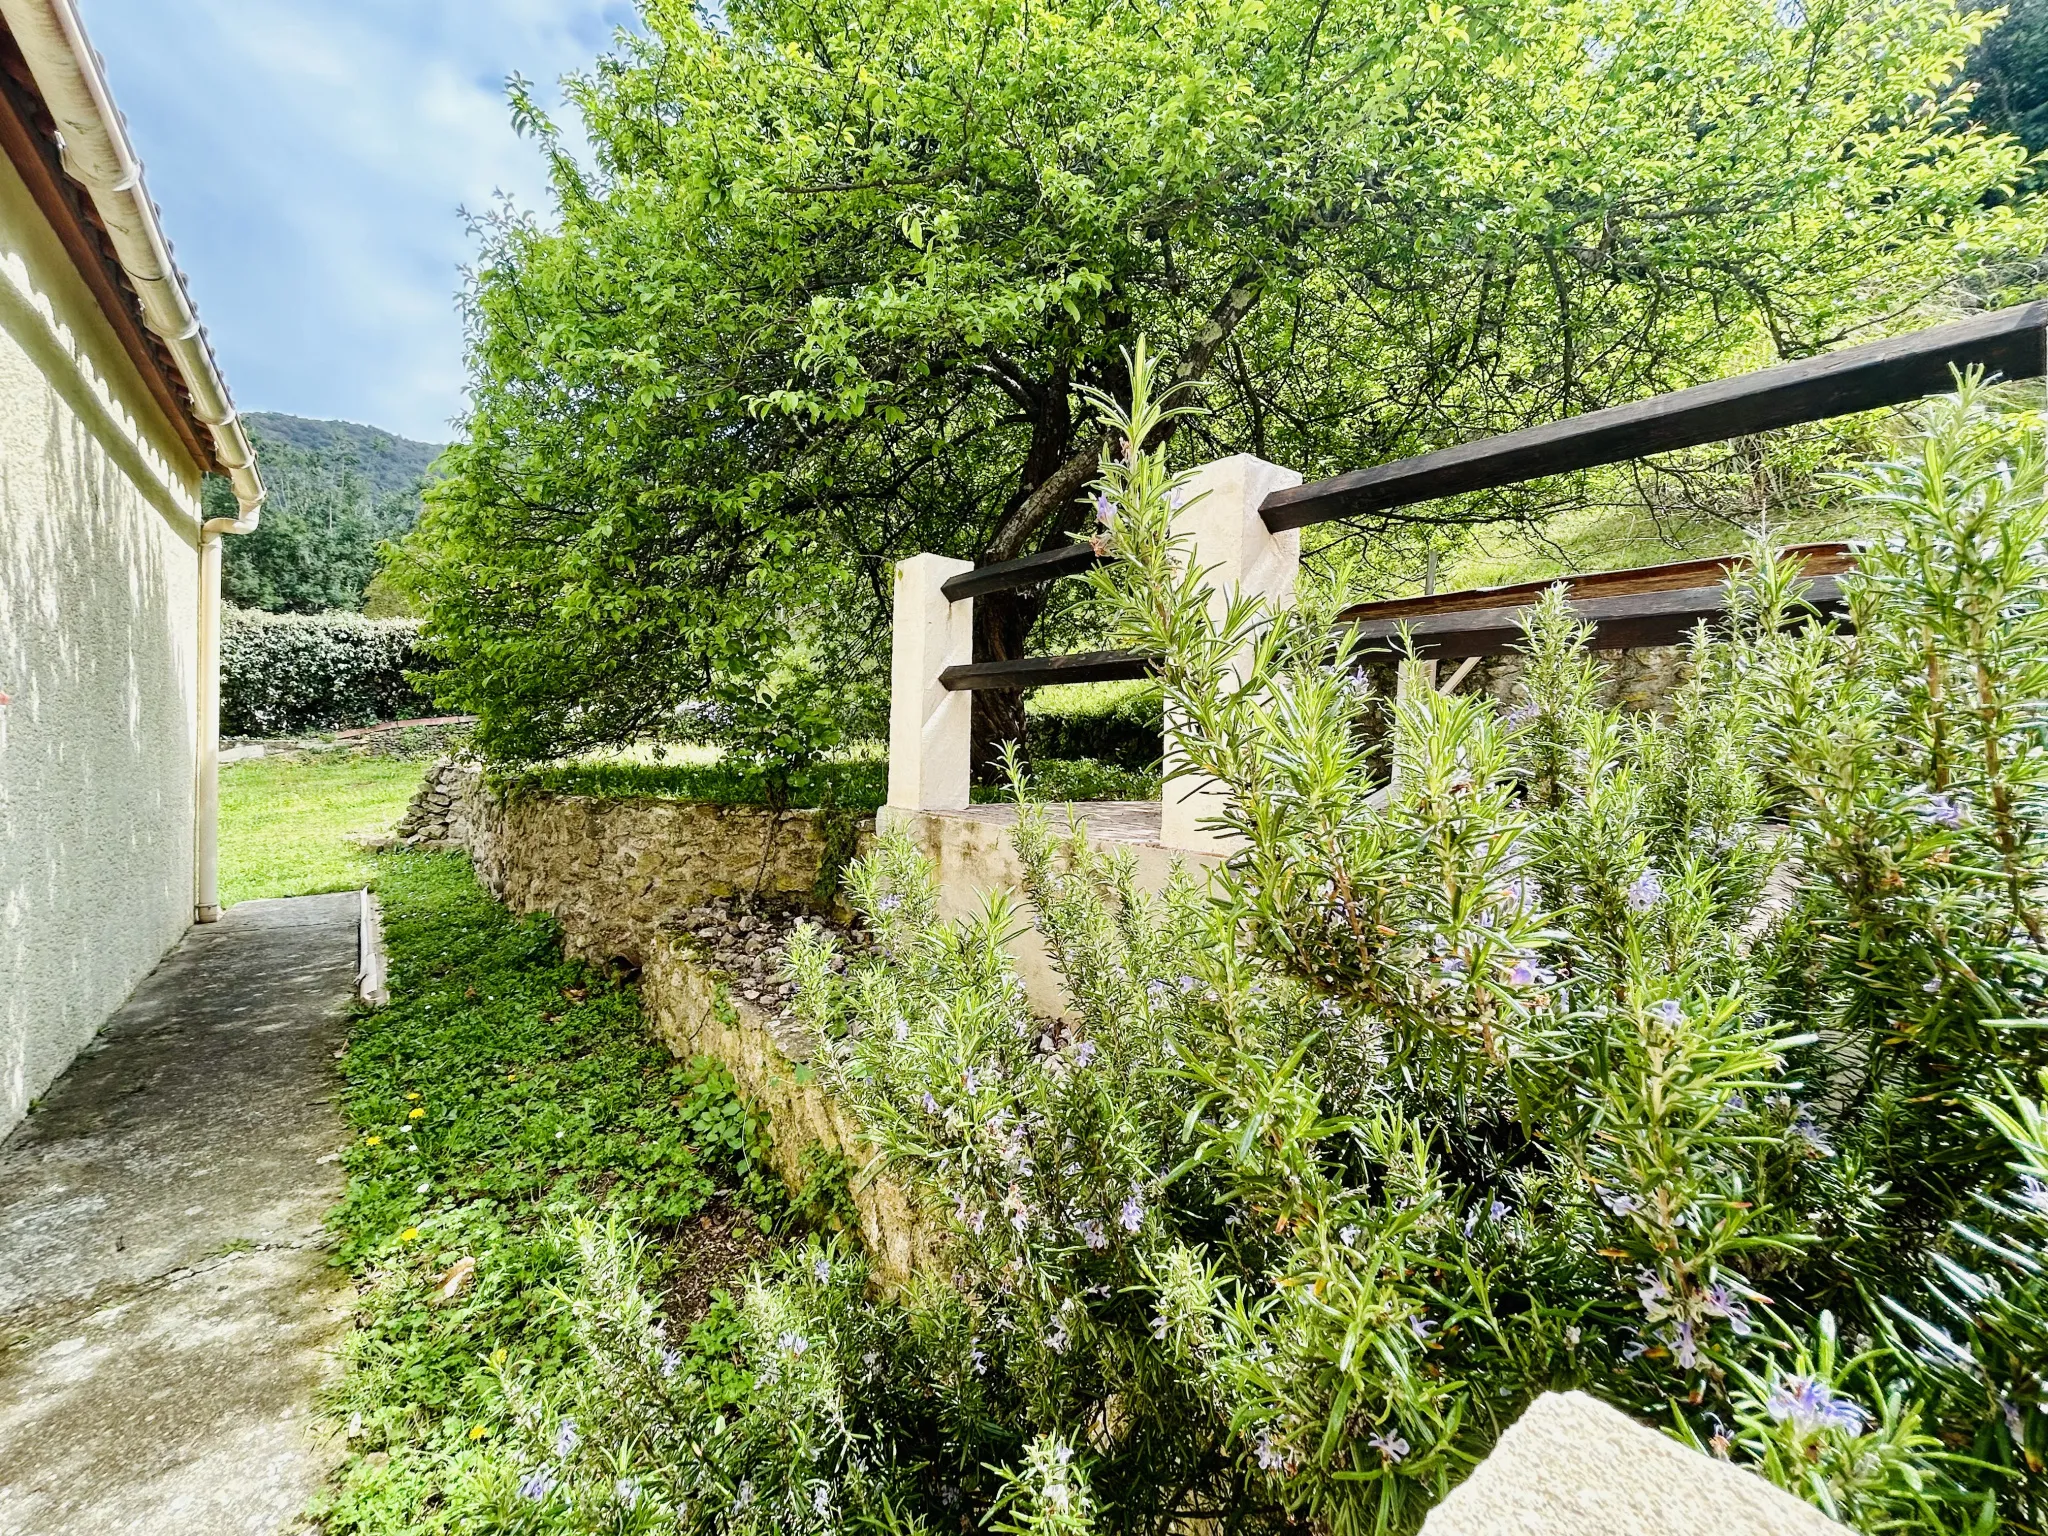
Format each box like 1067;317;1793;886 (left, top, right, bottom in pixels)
468;369;2048;1534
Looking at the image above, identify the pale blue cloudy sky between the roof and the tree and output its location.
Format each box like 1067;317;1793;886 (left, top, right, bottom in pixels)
80;0;633;442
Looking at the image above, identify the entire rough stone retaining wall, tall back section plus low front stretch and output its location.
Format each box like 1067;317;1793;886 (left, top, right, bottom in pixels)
399;758;940;1290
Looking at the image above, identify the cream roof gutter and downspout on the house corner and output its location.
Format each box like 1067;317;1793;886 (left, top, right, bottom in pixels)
0;0;264;924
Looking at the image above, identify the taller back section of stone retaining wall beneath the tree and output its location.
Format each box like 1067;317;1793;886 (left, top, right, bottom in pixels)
399;758;874;967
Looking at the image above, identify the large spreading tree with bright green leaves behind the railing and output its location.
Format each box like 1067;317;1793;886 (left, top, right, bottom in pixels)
410;0;2032;770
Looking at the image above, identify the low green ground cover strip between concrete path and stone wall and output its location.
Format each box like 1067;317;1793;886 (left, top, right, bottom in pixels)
319;854;778;1534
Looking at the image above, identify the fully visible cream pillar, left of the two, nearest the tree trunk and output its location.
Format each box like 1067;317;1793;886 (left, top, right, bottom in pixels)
881;555;975;829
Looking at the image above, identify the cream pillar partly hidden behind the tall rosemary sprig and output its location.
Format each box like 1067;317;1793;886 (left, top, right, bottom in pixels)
1159;453;1300;854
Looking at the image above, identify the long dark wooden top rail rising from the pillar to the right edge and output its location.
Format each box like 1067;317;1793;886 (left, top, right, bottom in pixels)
1260;301;2048;532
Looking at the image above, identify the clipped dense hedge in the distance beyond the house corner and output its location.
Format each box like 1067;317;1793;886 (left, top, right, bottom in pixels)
221;608;432;735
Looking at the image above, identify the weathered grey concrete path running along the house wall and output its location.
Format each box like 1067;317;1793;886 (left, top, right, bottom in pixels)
0;895;358;1536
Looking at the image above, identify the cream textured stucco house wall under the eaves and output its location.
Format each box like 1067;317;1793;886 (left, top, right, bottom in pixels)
0;160;199;1135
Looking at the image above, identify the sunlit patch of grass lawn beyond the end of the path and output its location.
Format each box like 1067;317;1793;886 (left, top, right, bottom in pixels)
221;752;426;907
